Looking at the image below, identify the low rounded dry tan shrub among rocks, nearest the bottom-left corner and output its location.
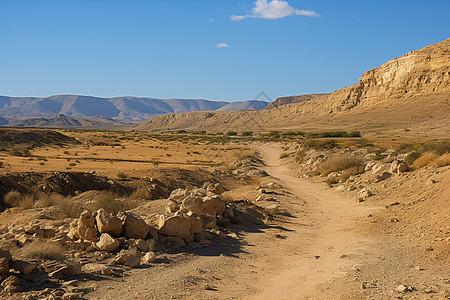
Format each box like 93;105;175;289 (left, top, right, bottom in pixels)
21;240;67;260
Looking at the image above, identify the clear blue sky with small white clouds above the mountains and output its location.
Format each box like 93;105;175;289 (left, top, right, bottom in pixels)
0;0;450;101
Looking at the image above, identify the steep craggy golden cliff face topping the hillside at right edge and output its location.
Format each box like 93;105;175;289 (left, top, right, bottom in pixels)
324;39;450;111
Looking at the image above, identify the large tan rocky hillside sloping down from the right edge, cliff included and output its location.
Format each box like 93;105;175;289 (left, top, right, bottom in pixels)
137;39;450;137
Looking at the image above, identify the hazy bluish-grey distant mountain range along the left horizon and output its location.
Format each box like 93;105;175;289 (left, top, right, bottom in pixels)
0;95;269;127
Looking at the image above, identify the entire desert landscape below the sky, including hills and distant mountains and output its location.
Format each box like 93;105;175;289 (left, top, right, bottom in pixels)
0;39;450;299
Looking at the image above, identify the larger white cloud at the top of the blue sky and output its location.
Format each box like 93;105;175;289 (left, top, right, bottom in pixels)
230;0;320;21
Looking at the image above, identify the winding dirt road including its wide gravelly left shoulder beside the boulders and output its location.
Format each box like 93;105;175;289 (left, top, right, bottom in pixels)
88;145;384;299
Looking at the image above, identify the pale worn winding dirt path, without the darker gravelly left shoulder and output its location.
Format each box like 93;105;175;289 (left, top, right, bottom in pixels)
236;146;375;299
